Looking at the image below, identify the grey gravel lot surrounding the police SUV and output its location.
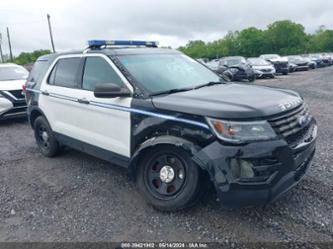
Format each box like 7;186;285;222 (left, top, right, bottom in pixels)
0;67;333;242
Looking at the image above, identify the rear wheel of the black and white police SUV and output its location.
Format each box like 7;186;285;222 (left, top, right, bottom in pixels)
34;116;61;157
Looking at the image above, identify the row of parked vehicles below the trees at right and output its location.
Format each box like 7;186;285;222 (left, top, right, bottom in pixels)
200;53;333;82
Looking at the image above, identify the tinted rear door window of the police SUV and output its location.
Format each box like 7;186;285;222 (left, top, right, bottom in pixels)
48;58;81;88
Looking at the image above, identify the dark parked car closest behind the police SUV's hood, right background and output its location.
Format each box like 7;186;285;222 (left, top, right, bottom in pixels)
220;56;256;82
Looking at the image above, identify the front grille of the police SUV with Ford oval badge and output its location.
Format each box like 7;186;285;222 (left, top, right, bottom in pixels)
269;105;313;145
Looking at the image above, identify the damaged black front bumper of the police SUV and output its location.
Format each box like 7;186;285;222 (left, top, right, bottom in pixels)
193;124;317;207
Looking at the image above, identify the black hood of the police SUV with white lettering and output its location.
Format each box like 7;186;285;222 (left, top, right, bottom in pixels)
152;83;303;119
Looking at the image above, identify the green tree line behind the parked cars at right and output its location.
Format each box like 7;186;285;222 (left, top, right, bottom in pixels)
178;20;333;59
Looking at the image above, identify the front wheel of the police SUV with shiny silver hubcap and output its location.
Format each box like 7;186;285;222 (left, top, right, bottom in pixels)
136;145;202;212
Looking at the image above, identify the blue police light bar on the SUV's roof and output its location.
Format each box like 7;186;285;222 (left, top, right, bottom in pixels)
88;40;158;48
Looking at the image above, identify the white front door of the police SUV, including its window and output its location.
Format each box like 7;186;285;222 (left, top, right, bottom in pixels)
75;54;133;157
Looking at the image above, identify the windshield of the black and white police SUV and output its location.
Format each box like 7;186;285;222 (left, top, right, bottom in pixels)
119;54;220;95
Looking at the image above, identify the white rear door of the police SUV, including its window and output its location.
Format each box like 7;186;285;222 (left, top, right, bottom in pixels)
39;55;83;142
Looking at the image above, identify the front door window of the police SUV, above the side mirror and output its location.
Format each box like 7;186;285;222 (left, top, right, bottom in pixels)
82;57;124;91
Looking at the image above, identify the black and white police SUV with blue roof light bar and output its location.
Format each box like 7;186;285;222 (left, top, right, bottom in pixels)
26;40;317;211
